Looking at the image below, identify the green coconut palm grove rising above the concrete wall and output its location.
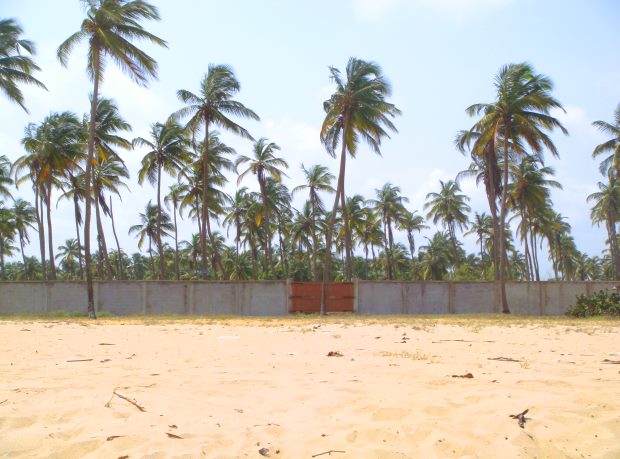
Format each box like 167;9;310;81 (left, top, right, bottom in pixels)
0;0;620;311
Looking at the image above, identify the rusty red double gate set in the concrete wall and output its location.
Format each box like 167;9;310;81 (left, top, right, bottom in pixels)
290;282;354;313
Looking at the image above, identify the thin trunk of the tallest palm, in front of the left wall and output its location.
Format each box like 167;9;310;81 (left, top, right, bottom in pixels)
84;49;100;319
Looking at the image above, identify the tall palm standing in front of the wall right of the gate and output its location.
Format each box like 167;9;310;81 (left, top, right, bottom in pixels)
466;63;568;313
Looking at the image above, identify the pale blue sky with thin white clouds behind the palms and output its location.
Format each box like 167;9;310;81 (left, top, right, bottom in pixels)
0;0;620;274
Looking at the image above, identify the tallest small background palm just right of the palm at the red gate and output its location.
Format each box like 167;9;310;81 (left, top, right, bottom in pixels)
368;183;409;280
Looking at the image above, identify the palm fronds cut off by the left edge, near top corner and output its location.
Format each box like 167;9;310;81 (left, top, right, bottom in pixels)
0;19;47;113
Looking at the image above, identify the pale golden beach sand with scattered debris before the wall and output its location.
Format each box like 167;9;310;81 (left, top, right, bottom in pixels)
0;317;620;459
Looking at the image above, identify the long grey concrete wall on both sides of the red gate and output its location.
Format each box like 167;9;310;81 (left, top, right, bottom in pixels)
0;281;620;316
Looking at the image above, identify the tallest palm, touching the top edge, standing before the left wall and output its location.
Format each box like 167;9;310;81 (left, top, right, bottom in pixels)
57;0;166;319
